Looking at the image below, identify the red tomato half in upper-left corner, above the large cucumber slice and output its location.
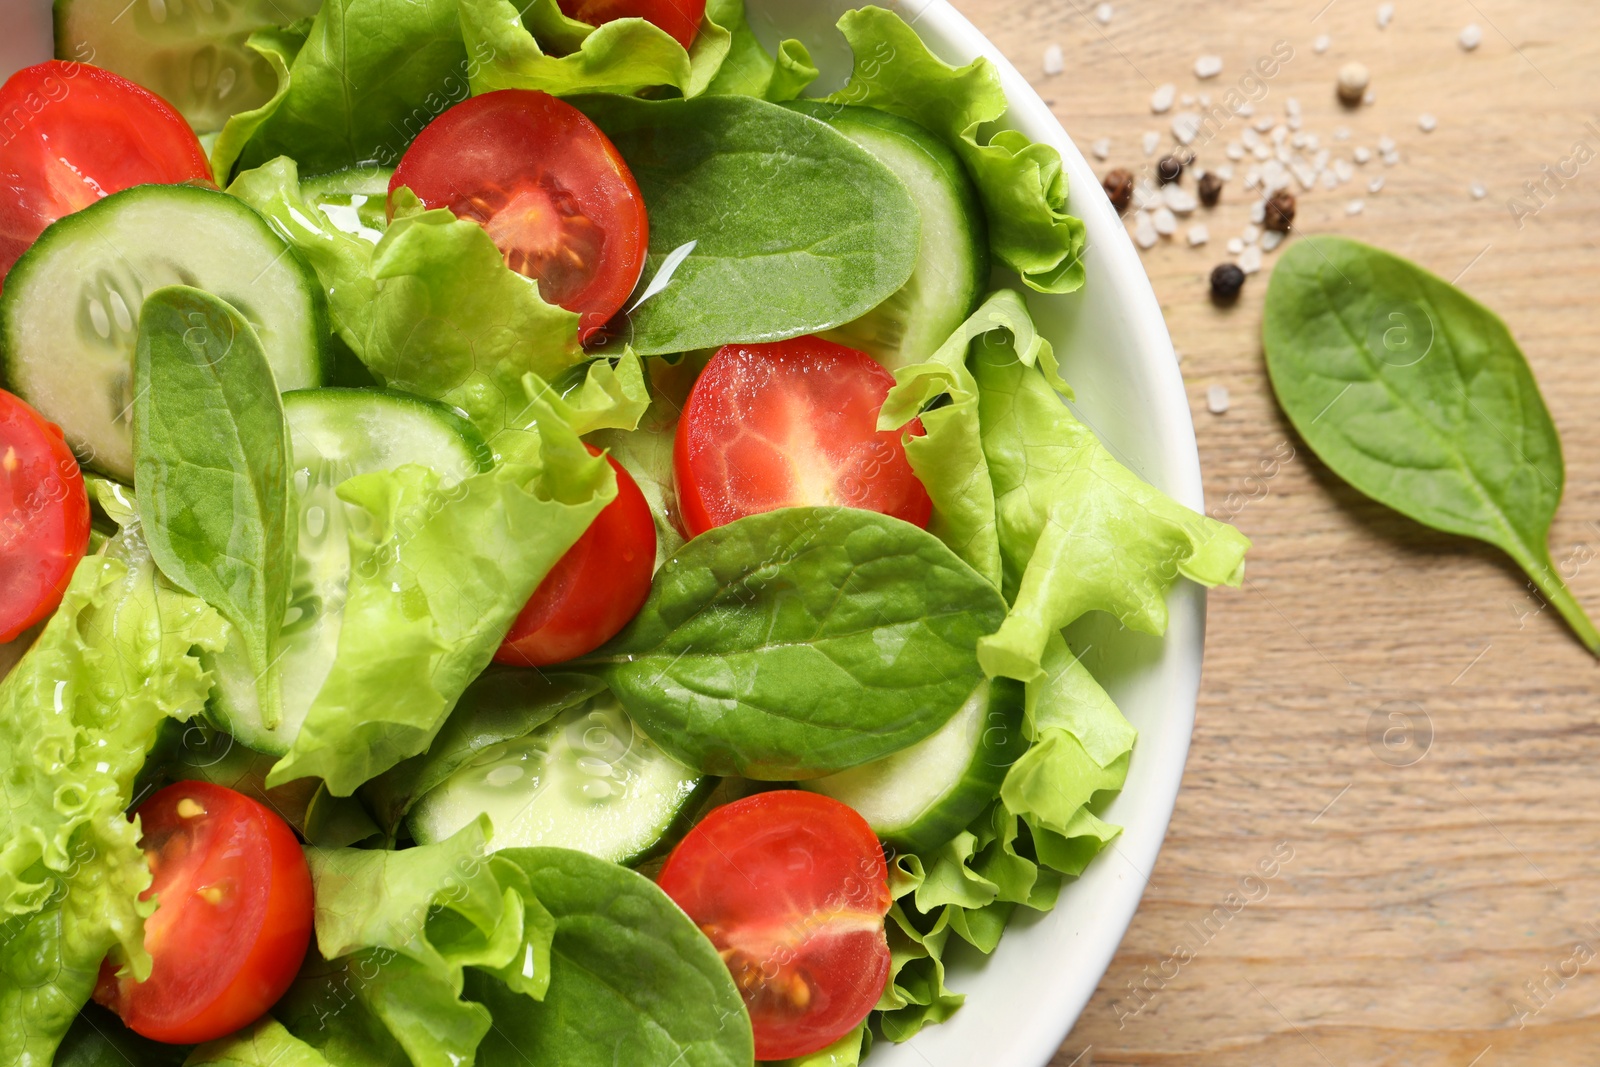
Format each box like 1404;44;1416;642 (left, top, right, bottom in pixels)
0;59;211;287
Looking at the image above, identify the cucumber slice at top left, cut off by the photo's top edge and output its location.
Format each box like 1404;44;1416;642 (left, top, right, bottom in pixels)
56;0;322;133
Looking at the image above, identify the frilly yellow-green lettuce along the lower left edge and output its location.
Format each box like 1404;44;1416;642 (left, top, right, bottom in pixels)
0;533;224;1064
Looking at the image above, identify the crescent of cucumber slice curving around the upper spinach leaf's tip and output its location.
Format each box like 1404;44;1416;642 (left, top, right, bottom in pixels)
790;101;989;371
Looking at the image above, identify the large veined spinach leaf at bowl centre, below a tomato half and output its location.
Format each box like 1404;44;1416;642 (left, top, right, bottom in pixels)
571;507;1005;781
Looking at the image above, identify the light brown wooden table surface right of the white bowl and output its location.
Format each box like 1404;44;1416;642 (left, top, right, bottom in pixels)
955;0;1600;1067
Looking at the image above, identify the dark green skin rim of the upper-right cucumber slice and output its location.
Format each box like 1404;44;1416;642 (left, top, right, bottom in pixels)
784;101;990;370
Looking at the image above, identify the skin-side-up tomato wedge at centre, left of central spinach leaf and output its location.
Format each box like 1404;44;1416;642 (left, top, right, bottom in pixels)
494;445;656;667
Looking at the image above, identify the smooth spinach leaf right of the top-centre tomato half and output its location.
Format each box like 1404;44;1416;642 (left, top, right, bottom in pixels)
571;96;922;355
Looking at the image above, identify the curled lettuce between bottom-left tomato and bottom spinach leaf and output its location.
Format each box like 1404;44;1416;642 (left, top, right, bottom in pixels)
274;819;555;1067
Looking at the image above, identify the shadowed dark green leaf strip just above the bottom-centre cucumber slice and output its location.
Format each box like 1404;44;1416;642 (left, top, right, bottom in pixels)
362;667;605;833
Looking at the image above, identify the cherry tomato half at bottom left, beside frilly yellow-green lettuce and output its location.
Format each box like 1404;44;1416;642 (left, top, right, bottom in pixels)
94;782;312;1045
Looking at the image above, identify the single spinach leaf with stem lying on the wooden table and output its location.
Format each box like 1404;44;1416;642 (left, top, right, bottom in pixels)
1262;237;1600;656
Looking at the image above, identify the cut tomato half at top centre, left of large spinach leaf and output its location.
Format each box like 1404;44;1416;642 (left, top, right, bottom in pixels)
389;90;650;339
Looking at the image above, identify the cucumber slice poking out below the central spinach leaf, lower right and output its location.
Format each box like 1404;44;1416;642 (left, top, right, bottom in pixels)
800;678;1027;853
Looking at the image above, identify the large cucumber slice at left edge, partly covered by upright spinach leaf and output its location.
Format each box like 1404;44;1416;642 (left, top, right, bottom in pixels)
0;186;328;483
